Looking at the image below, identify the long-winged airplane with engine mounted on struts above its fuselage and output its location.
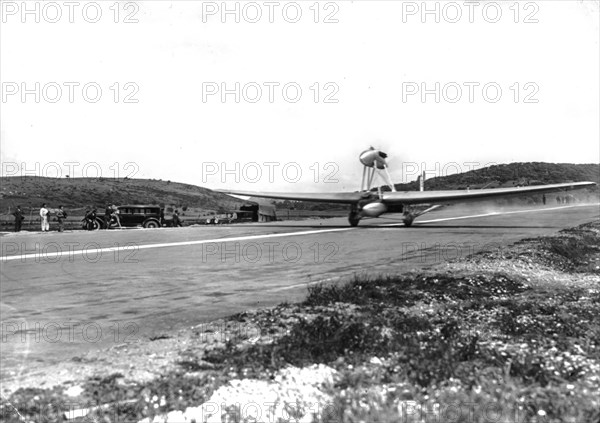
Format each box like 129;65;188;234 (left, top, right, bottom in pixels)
216;147;596;226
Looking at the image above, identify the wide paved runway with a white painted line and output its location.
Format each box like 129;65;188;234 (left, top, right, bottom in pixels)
0;204;599;380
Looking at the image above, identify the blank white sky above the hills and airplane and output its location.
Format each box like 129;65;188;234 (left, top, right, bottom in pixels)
0;0;600;192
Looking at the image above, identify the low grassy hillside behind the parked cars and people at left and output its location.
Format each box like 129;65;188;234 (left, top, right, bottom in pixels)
0;176;244;213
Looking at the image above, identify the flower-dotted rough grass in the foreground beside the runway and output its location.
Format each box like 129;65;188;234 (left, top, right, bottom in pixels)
6;221;600;423
